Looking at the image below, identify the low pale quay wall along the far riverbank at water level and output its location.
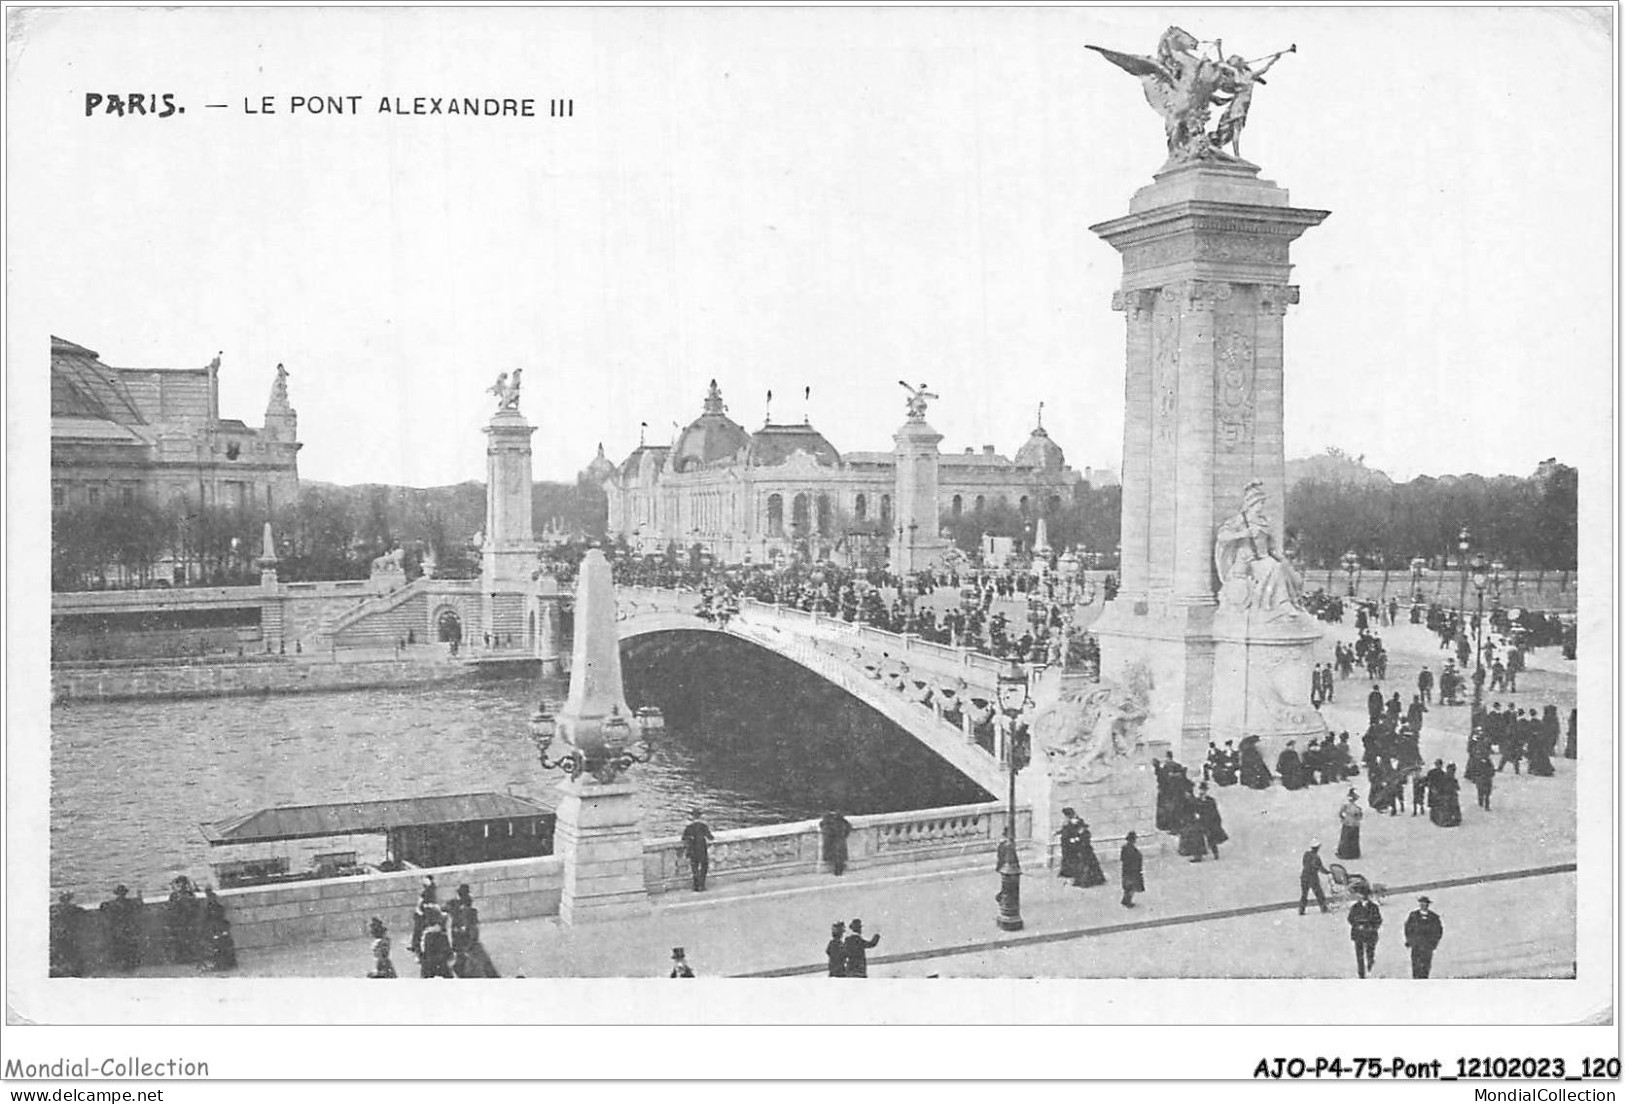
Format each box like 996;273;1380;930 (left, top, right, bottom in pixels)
50;657;471;704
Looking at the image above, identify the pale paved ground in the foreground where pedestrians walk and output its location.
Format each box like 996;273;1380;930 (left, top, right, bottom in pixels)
126;608;1573;979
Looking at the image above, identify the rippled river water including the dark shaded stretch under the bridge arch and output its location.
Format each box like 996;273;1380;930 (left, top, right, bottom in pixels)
50;634;988;902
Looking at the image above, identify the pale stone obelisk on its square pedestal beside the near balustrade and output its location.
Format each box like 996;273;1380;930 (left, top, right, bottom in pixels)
553;548;648;924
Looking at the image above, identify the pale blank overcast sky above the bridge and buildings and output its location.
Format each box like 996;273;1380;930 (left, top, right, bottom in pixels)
8;8;1615;485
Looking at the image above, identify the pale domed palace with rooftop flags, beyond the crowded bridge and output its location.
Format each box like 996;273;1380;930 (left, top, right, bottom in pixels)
605;380;1084;563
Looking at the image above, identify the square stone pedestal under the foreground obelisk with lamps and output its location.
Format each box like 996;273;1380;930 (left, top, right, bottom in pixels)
553;777;648;924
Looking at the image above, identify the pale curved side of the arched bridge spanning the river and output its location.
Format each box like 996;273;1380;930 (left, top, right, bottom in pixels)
616;587;1060;803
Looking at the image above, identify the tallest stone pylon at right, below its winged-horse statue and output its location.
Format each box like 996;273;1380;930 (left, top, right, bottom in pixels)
1090;159;1328;759
